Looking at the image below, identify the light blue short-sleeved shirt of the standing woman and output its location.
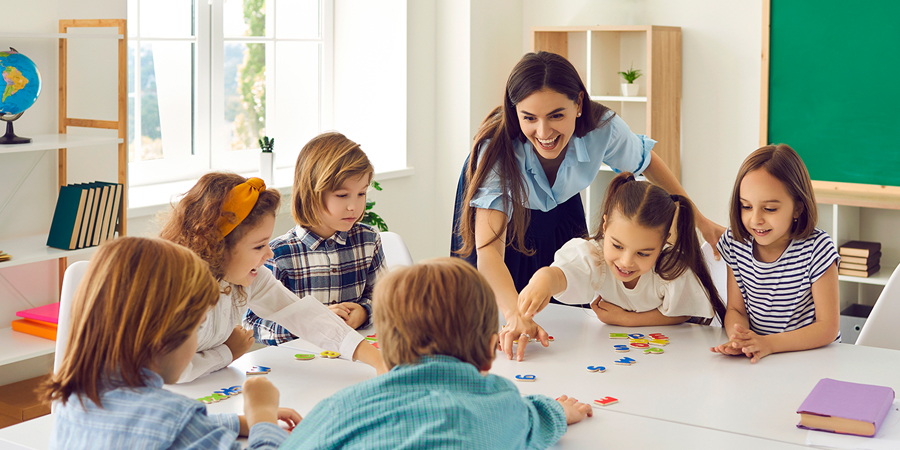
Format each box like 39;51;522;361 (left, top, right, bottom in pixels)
469;114;656;217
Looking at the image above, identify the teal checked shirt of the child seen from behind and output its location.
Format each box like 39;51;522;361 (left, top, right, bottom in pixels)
281;355;566;450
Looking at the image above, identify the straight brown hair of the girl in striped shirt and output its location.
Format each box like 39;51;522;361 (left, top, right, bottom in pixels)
729;144;819;242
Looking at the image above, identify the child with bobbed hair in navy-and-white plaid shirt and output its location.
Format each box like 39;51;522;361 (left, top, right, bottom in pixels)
243;133;384;345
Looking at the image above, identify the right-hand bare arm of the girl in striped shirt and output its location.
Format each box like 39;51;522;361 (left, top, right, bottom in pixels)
737;263;840;362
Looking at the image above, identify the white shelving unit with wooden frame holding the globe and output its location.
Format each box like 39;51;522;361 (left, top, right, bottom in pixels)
0;19;128;382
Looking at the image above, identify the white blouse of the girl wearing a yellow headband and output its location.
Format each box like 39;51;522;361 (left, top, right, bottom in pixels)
178;267;363;383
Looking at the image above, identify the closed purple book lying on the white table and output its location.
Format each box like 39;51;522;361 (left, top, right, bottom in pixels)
797;378;894;436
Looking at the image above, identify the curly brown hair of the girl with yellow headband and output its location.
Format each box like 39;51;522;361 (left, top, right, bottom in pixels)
159;172;281;302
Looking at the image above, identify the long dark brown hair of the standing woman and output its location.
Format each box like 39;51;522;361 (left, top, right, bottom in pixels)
457;52;615;257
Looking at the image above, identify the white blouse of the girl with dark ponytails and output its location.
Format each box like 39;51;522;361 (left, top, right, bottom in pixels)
551;238;714;318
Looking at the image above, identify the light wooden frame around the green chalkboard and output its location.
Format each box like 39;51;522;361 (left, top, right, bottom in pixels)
759;0;900;209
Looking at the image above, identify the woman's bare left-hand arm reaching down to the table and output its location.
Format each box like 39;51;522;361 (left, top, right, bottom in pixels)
475;208;550;361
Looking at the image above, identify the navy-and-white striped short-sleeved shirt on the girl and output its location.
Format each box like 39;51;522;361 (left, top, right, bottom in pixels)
717;228;841;342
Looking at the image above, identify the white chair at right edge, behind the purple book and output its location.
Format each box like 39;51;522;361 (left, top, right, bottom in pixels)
856;266;900;350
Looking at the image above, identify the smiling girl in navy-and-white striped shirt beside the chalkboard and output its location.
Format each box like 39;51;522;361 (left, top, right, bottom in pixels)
710;144;841;363
